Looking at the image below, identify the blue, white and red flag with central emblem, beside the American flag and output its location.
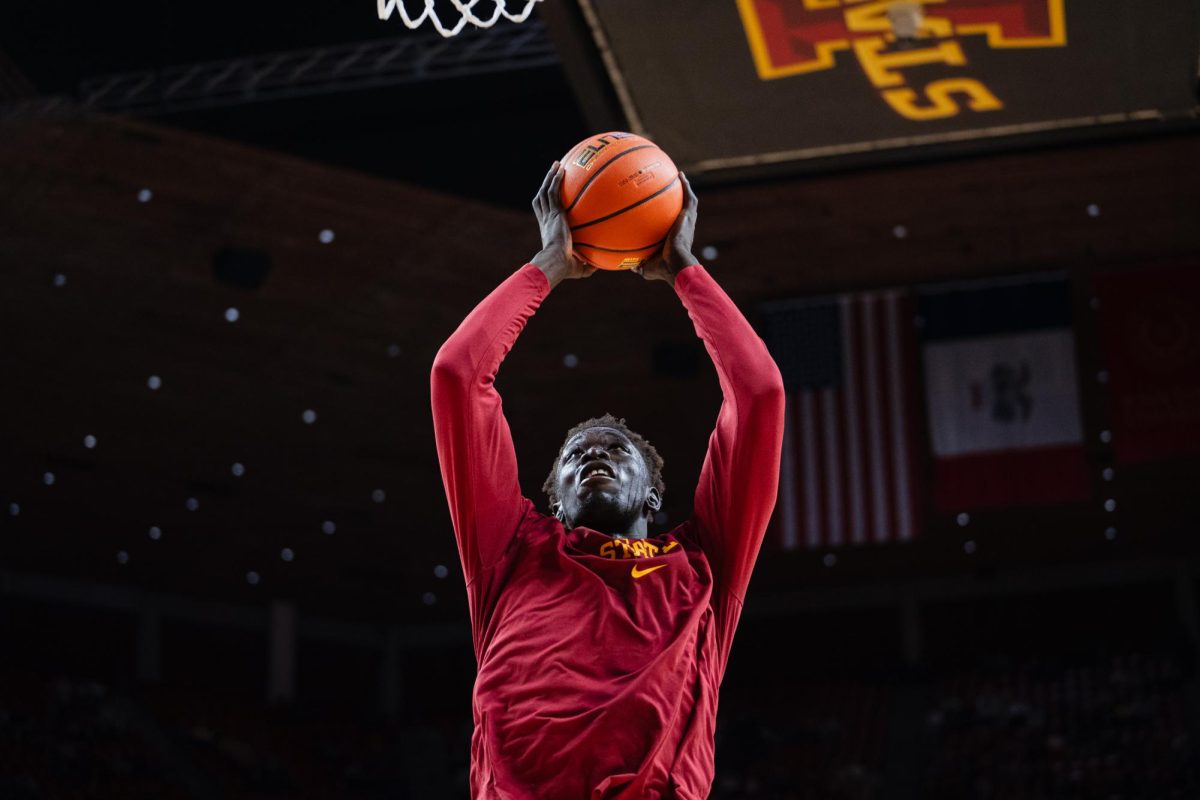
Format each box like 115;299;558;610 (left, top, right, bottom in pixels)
917;276;1088;512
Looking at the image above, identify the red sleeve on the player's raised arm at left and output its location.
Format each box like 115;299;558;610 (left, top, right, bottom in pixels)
431;264;550;585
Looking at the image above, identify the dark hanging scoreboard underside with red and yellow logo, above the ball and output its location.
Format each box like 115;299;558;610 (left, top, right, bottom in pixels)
544;0;1200;181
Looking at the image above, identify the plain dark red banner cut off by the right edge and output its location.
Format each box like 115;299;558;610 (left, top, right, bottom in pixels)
1093;260;1200;463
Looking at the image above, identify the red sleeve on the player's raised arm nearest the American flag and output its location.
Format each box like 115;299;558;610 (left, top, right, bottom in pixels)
674;264;784;602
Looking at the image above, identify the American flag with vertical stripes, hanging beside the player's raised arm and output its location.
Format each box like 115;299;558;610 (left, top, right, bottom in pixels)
763;289;924;549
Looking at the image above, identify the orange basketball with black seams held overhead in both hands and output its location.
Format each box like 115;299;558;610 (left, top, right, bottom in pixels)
562;131;683;270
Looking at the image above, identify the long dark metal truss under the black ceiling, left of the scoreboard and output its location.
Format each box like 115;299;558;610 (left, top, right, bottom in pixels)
79;19;558;115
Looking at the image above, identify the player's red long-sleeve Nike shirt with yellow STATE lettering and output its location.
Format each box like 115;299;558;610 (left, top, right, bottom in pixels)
432;265;784;800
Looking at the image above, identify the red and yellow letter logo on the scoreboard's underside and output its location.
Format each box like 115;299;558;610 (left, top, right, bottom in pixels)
738;0;1067;121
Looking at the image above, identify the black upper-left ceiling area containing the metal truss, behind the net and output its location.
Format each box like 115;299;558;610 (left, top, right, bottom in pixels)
0;0;590;210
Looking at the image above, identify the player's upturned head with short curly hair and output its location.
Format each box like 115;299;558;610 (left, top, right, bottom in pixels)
558;428;658;534
